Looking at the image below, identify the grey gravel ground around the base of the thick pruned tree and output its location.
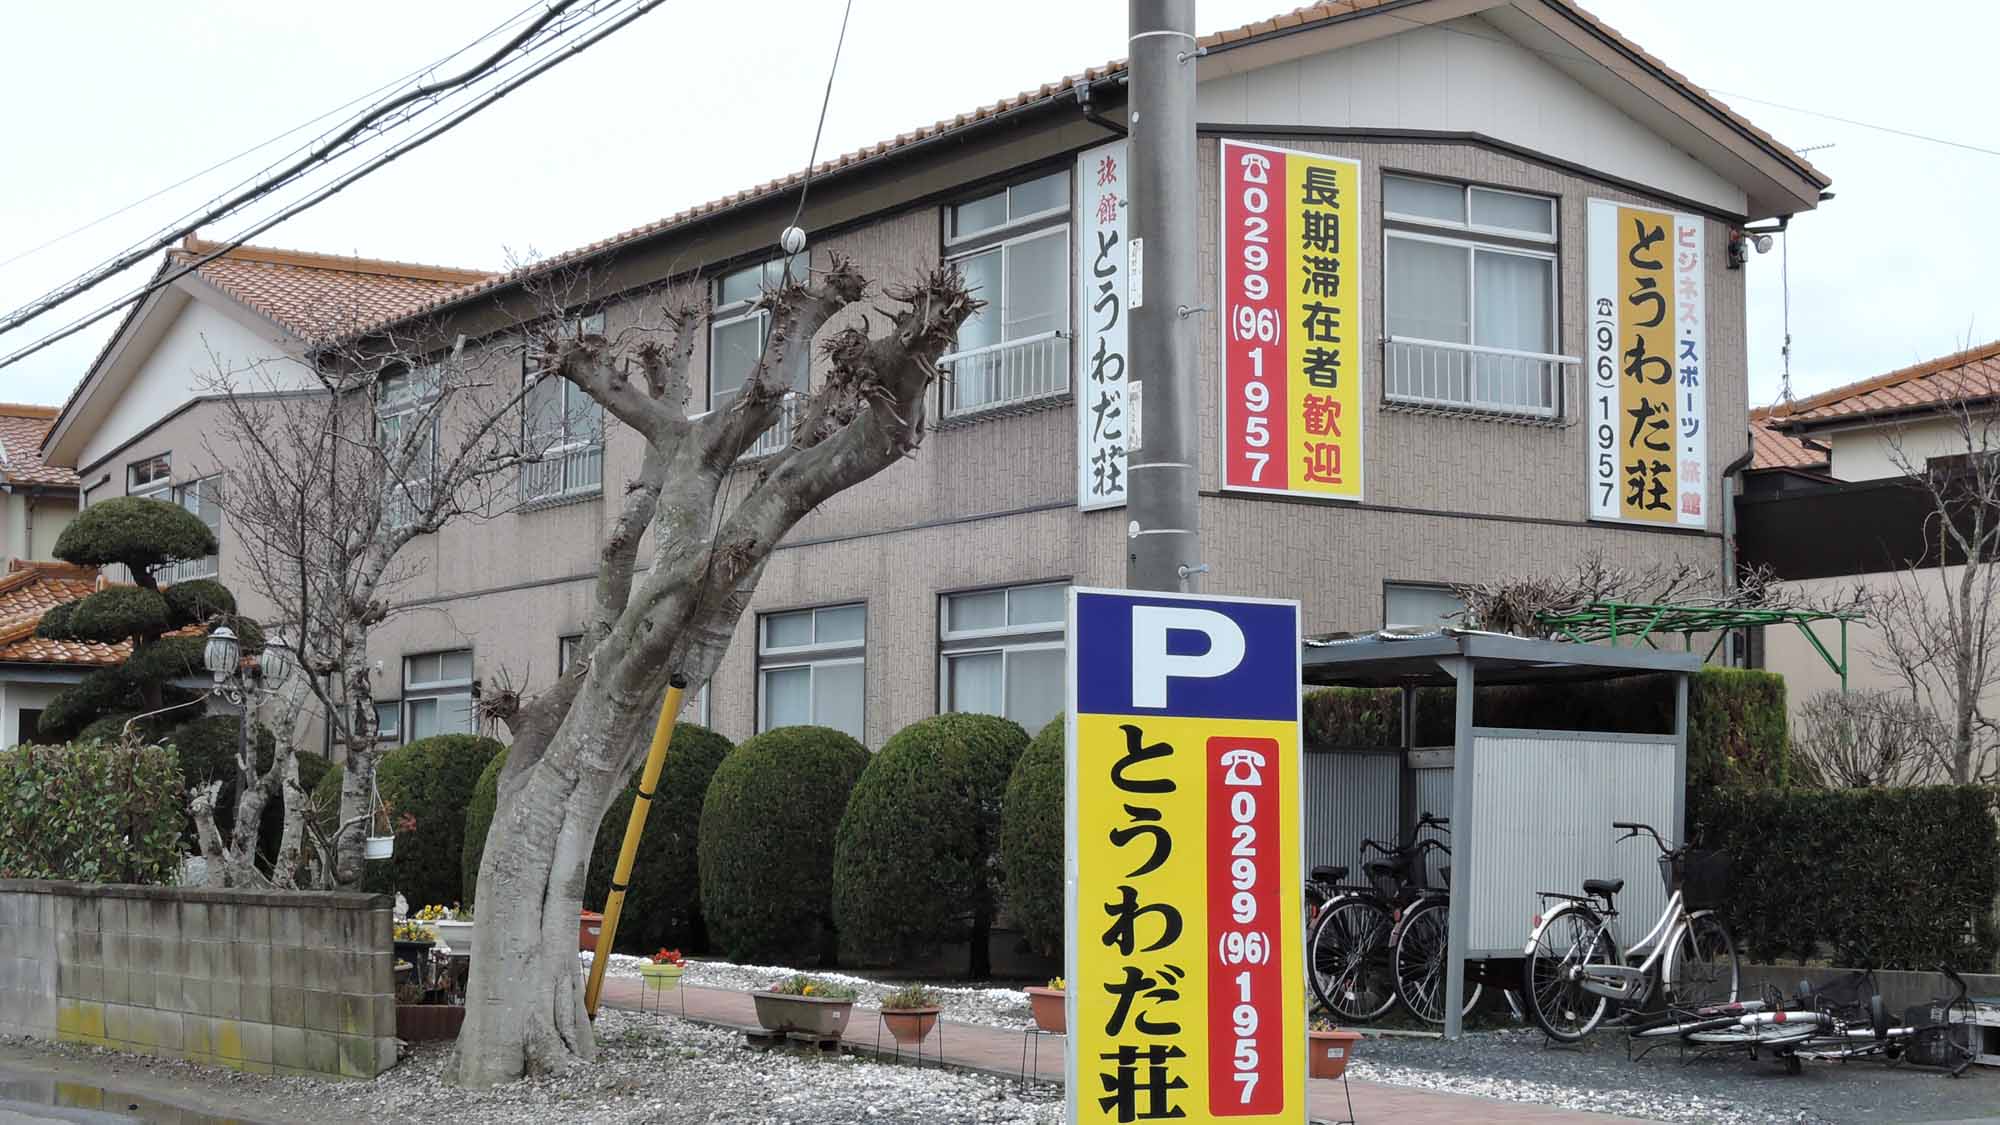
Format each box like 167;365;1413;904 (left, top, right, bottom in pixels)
7;1009;1062;1125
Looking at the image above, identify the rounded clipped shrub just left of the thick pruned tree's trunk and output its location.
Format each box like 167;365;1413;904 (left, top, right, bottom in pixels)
376;735;502;909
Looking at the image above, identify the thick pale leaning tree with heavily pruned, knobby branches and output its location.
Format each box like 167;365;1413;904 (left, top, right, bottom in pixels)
458;256;980;1085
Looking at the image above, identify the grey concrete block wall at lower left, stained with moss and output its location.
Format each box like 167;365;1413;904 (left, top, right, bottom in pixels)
0;879;396;1079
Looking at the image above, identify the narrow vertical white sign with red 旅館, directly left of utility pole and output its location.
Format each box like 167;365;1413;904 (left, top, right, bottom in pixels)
1072;140;1138;512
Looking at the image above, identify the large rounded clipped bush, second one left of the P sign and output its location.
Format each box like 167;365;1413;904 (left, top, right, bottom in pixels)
834;715;1028;977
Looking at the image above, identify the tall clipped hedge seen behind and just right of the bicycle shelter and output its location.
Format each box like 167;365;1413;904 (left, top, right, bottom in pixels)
1306;667;1790;787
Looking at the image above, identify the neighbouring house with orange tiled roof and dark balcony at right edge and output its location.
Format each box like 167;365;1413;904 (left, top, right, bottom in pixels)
1738;342;2000;764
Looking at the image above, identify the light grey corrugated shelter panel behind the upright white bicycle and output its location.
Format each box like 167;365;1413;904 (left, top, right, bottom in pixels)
1454;735;1680;953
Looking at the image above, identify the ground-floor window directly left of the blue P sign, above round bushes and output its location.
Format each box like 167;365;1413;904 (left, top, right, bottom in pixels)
938;583;1066;735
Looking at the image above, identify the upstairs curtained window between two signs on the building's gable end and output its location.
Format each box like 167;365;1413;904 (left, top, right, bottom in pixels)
1382;176;1566;416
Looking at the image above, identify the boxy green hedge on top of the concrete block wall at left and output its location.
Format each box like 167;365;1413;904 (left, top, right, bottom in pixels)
0;743;186;885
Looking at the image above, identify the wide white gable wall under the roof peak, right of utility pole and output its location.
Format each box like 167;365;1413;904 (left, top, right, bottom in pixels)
1196;16;1748;214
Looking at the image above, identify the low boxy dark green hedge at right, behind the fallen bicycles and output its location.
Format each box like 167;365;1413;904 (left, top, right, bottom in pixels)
1688;785;2000;973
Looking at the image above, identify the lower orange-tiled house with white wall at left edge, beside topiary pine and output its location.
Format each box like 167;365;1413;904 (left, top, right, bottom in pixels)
0;558;121;747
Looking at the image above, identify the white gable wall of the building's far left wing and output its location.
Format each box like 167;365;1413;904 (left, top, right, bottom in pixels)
76;296;310;464
